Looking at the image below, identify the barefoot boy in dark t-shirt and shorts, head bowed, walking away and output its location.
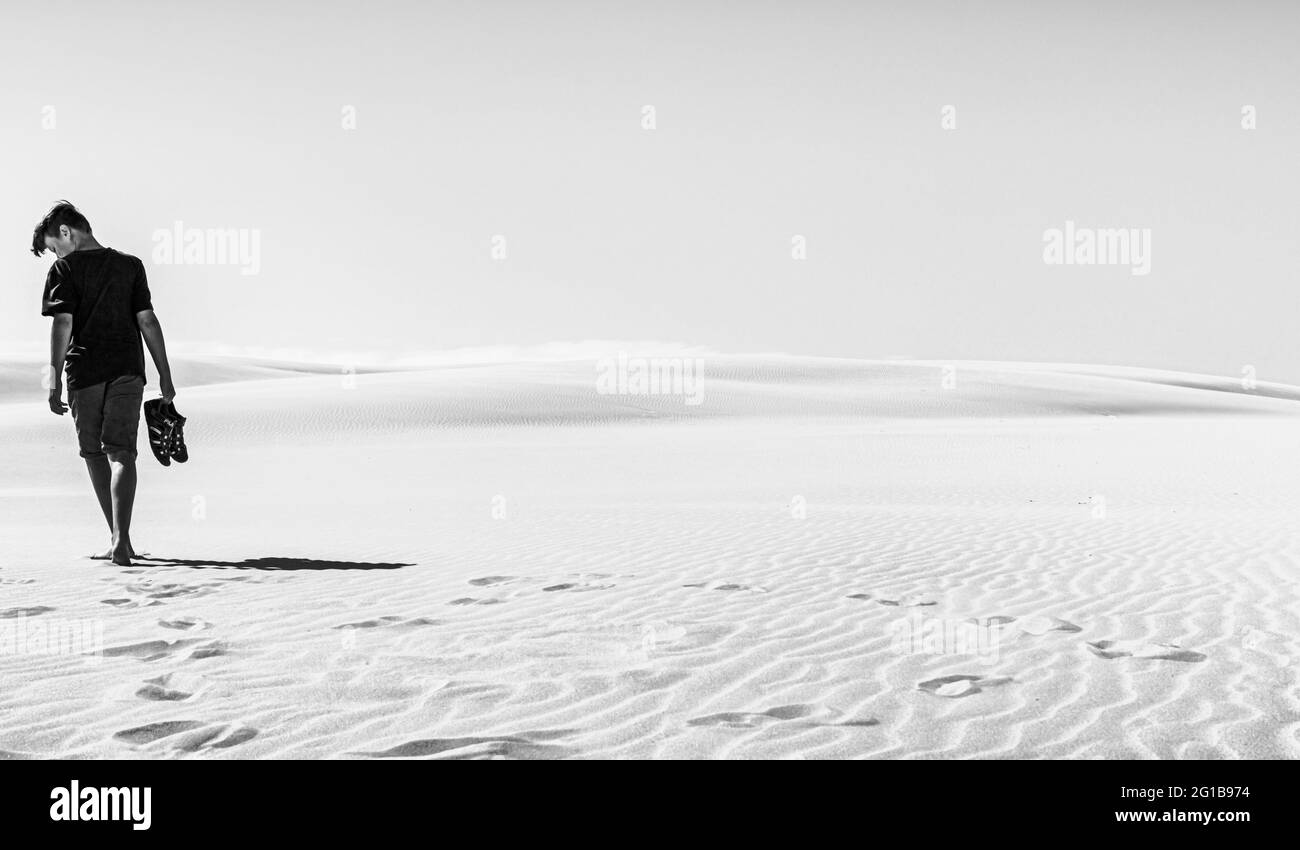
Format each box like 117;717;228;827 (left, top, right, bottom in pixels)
31;201;176;567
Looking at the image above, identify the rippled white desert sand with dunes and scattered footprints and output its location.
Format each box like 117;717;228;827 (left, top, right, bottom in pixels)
0;357;1300;758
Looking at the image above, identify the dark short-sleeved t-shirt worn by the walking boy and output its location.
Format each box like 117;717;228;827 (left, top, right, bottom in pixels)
40;248;153;390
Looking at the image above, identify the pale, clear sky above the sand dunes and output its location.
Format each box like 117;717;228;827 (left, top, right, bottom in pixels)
0;0;1300;383
